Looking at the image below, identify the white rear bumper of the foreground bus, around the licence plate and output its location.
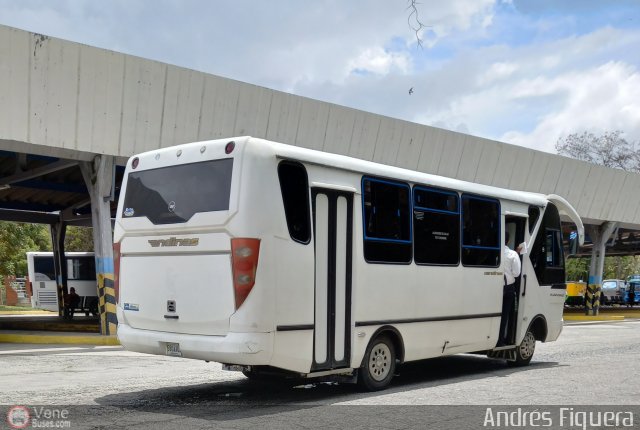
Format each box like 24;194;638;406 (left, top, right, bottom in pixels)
118;323;273;366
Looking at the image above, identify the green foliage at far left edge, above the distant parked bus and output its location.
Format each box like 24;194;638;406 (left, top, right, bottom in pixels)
0;221;51;278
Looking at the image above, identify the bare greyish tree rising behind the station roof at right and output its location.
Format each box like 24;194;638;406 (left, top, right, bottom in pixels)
556;130;640;172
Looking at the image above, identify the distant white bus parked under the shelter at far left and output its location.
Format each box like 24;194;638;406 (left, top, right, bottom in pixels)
27;252;98;313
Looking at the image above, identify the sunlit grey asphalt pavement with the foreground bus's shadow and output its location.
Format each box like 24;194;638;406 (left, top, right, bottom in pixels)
0;321;640;429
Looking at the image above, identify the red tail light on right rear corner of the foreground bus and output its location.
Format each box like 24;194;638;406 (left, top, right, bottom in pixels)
231;238;260;310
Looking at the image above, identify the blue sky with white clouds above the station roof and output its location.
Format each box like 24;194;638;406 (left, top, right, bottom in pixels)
0;0;640;152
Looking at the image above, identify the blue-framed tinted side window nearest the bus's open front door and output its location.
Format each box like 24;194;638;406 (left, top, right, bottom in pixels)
462;195;502;267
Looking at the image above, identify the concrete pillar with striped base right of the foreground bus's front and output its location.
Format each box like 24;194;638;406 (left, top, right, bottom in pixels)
585;222;617;315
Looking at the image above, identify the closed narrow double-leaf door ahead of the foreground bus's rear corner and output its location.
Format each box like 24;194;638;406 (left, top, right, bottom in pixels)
311;188;353;371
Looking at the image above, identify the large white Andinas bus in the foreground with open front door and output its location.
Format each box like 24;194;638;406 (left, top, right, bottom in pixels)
114;137;583;390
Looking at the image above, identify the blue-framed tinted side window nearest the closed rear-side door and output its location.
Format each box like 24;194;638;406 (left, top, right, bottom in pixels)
362;178;411;263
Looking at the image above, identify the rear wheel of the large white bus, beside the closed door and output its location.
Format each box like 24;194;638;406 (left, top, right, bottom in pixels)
358;335;396;391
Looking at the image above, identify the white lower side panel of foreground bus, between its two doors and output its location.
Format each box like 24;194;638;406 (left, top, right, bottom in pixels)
351;191;503;367
